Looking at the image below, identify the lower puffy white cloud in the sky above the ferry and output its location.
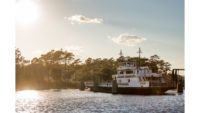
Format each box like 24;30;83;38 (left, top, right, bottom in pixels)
110;34;146;46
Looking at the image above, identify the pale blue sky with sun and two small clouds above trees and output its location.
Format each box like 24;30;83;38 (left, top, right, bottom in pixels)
16;0;184;68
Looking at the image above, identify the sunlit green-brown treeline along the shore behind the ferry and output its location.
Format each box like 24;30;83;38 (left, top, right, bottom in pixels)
15;49;171;90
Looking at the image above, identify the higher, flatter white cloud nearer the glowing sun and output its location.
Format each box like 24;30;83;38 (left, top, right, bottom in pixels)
64;15;103;24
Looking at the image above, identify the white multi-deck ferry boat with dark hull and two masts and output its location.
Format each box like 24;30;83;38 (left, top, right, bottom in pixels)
82;48;175;94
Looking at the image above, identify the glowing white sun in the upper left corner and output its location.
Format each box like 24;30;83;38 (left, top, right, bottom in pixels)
16;0;38;24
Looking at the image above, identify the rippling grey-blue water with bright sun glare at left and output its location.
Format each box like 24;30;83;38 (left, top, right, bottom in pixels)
16;89;184;113
